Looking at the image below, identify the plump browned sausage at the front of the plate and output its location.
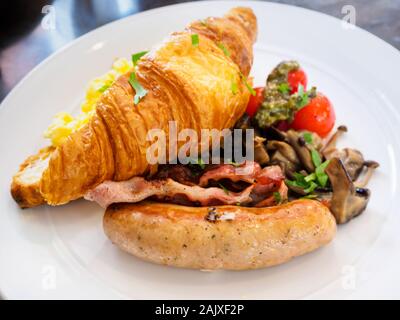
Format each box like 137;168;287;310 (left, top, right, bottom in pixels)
104;200;336;270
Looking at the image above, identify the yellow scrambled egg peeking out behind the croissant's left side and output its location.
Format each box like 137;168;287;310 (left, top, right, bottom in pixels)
44;58;133;147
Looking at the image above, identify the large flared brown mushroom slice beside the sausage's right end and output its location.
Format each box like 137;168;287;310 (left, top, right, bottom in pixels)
325;158;370;224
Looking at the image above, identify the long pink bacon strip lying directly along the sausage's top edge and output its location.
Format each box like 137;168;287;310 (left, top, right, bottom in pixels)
85;166;286;208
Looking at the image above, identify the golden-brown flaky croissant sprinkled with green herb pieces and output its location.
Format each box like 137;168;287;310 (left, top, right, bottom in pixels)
11;8;257;207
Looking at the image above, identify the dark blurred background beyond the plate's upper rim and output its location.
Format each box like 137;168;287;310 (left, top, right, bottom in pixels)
0;0;400;101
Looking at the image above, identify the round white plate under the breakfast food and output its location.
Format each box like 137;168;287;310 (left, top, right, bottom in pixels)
0;2;400;299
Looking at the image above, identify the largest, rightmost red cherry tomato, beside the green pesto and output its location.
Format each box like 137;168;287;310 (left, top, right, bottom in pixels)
291;92;336;138
